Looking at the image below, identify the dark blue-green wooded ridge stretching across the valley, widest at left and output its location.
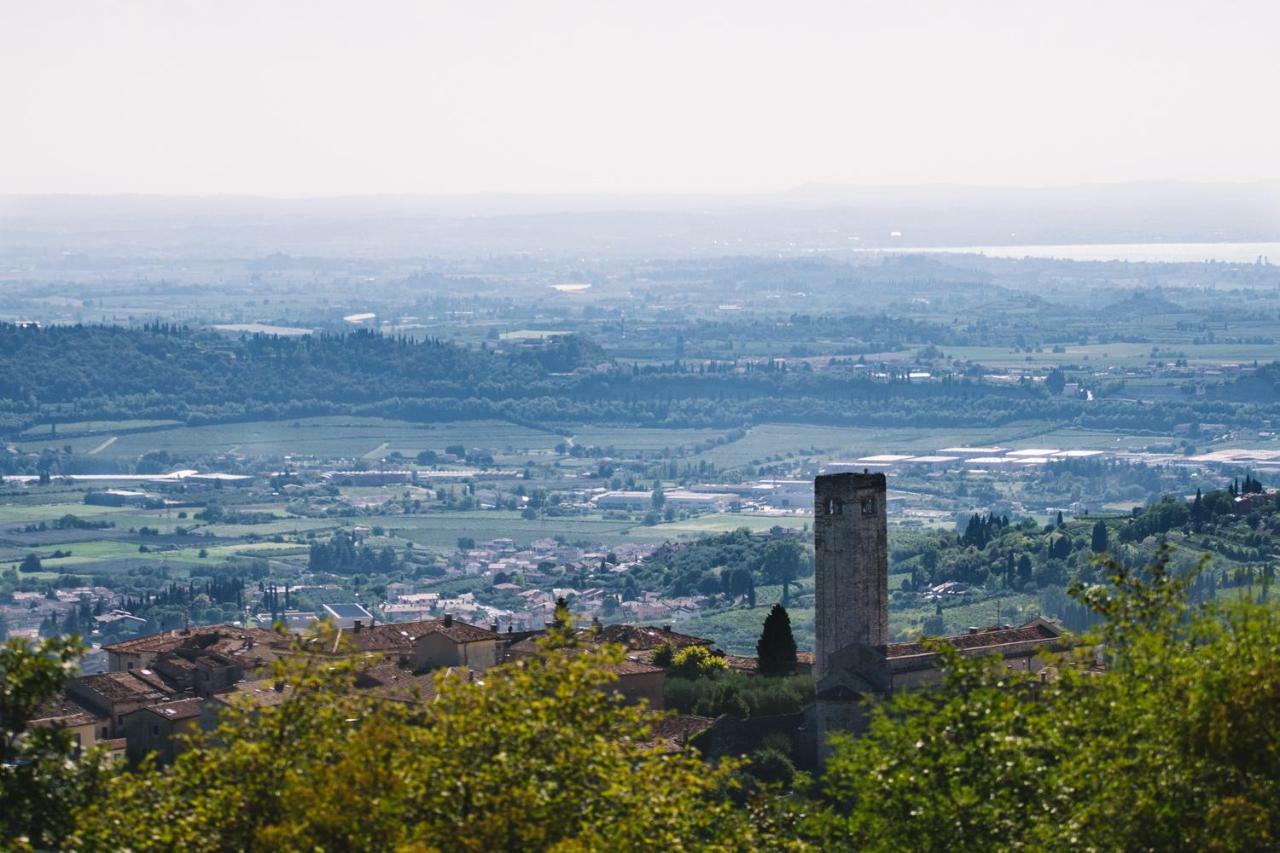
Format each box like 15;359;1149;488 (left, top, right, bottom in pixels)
0;324;1280;433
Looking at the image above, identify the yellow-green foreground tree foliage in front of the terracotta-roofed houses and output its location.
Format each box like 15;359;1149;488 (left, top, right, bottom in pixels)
74;625;763;850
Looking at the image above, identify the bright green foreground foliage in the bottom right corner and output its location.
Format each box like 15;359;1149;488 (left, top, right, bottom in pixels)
809;553;1280;850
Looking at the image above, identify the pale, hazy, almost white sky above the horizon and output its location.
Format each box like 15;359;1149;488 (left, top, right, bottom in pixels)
0;0;1280;196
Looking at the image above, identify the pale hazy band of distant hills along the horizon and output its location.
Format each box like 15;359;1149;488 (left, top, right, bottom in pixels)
0;182;1280;257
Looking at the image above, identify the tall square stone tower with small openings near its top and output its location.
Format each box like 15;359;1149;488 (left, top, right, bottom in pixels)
813;474;888;681
